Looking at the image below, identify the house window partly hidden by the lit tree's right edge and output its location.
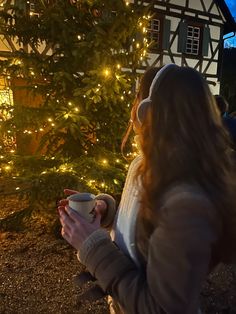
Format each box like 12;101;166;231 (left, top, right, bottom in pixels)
147;18;161;51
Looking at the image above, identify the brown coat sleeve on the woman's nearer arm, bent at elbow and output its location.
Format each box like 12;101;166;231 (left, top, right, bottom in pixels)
78;195;217;314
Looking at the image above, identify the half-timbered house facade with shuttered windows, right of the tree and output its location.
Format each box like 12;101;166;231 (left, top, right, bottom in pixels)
133;0;236;94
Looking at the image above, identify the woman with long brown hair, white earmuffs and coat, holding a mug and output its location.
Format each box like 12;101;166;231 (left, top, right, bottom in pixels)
59;65;236;314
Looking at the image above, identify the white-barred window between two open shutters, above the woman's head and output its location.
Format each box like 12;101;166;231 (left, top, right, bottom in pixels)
185;25;201;55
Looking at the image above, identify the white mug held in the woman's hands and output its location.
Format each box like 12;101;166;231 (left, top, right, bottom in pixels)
67;193;96;222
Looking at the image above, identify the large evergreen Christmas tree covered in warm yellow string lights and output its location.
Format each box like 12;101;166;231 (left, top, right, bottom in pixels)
0;0;150;229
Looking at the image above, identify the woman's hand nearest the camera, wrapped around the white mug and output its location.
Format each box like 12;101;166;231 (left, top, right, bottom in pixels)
58;206;101;251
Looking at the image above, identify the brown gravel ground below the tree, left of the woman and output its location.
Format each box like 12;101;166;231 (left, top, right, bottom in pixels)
0;228;108;314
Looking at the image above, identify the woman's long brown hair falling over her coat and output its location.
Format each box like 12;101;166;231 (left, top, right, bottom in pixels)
137;67;236;262
